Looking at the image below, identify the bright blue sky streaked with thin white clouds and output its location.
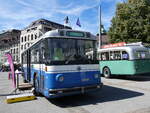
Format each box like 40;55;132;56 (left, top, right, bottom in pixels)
0;0;121;33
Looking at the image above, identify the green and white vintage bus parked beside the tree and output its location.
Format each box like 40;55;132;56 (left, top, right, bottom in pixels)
98;44;150;78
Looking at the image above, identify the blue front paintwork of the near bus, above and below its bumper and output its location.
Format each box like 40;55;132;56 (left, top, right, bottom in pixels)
44;71;101;98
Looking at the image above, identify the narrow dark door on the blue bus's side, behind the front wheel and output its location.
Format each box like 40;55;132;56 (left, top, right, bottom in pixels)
27;50;31;82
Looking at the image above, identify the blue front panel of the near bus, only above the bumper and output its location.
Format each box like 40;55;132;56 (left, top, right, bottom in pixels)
45;71;100;89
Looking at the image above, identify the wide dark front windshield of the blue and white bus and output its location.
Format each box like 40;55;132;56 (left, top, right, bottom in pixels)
43;38;98;65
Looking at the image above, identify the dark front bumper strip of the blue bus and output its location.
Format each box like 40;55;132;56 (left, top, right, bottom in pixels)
49;83;103;98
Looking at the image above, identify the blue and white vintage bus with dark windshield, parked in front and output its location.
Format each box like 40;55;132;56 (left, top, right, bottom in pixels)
22;29;102;98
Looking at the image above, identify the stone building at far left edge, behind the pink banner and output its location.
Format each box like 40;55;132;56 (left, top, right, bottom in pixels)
0;29;21;64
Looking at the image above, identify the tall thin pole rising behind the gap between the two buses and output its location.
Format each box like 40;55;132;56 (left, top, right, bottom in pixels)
99;0;102;49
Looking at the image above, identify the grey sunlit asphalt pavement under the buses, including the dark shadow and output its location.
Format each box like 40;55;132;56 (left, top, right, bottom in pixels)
0;73;150;113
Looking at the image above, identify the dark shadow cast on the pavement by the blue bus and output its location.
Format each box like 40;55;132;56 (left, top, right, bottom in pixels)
49;85;144;108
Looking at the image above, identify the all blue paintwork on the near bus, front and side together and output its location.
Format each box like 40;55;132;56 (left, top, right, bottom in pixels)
24;68;101;98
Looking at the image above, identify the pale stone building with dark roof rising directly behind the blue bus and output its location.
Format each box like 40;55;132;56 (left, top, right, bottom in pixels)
20;19;71;58
